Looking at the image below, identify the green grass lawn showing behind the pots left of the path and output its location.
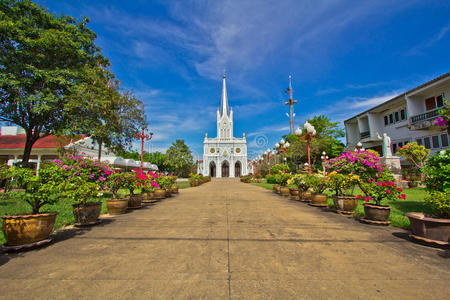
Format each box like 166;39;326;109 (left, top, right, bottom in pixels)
0;182;190;244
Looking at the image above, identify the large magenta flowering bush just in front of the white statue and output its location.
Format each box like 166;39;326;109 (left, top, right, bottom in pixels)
325;151;388;181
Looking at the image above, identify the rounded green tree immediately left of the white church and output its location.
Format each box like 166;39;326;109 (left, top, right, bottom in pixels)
165;140;194;177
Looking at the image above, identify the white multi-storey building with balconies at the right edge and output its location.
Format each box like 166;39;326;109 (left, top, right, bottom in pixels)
344;72;450;159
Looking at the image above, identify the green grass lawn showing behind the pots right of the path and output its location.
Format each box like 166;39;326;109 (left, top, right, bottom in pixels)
252;181;432;228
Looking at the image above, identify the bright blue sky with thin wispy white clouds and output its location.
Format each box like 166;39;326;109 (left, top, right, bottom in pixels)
37;0;450;159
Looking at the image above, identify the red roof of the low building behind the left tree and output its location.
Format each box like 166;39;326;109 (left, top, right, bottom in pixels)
0;135;77;149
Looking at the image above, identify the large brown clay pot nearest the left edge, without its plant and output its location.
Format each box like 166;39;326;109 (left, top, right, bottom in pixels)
2;212;58;246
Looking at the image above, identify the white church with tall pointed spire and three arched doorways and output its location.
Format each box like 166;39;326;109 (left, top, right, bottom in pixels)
197;75;250;178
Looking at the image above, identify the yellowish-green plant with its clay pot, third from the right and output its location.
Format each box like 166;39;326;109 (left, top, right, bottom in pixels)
326;171;359;214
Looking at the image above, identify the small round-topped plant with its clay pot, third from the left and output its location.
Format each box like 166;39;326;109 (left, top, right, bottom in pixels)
106;170;129;215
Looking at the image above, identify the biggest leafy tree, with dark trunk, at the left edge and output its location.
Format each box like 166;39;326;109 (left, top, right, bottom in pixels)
0;0;107;163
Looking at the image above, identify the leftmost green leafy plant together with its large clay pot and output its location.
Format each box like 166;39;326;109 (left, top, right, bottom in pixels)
2;164;60;247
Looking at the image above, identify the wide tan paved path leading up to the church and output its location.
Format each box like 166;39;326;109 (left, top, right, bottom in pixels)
0;180;450;299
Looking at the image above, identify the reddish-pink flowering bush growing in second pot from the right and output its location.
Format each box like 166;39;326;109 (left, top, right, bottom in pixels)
357;173;406;205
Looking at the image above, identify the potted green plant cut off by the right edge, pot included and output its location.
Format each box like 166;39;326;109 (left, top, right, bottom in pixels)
406;150;450;246
